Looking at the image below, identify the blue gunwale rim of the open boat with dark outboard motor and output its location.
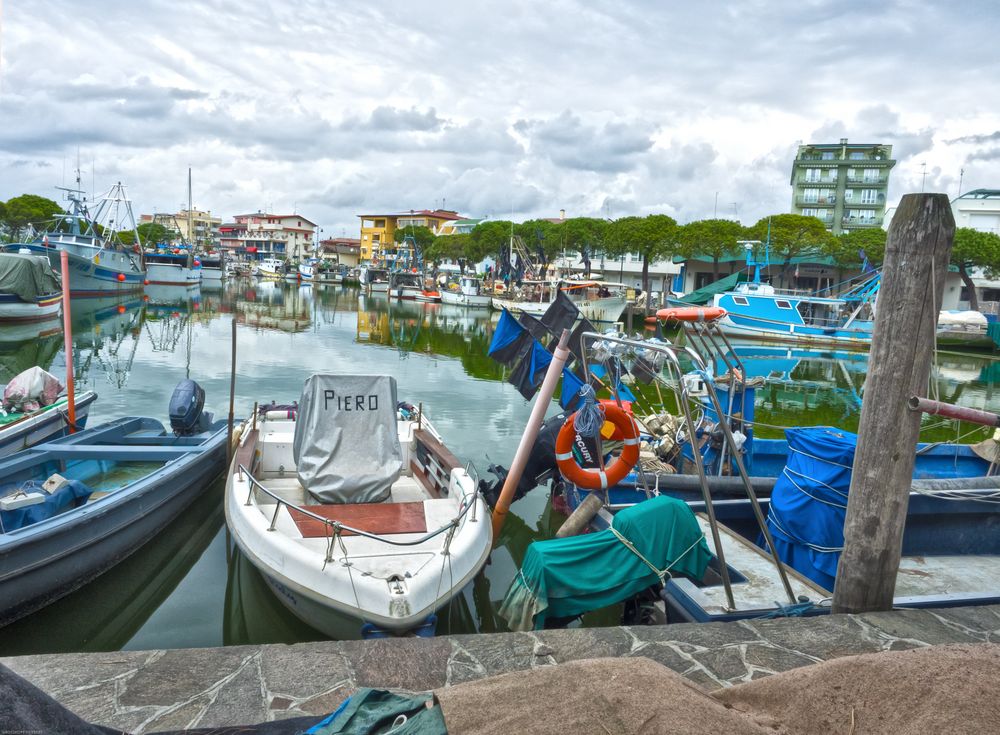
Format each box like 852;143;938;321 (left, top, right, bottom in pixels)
0;418;228;540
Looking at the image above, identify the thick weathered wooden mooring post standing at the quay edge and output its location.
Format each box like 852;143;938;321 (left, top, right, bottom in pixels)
833;194;955;613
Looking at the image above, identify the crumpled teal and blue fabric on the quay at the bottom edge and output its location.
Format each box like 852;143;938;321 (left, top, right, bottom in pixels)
304;687;448;735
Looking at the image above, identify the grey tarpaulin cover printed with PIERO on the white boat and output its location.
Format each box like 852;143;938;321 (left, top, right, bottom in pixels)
292;374;403;503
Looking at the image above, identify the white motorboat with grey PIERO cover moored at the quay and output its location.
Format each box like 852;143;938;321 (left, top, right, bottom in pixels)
225;375;492;638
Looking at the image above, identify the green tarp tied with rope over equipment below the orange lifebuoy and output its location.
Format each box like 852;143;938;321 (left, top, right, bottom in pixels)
500;495;712;630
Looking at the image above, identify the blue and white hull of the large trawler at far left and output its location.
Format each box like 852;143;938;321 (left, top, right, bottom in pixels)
9;243;146;298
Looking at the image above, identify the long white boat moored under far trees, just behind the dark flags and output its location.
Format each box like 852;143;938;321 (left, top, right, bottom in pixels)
492;280;628;322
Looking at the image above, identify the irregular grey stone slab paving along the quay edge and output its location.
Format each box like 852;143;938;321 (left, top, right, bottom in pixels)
0;606;1000;733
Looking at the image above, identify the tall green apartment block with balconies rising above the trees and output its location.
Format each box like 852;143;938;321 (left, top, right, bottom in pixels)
789;138;896;235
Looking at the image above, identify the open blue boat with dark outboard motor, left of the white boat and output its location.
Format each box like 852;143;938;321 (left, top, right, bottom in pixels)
0;381;240;625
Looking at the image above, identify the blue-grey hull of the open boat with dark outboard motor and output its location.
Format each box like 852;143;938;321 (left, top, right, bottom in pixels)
0;419;232;625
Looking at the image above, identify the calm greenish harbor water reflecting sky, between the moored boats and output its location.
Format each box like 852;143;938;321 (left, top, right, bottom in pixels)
0;281;1000;655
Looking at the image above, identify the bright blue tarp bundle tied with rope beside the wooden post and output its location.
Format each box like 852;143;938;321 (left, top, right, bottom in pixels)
767;426;858;590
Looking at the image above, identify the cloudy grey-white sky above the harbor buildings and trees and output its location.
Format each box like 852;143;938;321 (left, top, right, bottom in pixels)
0;0;1000;237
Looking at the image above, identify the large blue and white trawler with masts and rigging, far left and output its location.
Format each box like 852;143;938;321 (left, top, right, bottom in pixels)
5;177;146;297
